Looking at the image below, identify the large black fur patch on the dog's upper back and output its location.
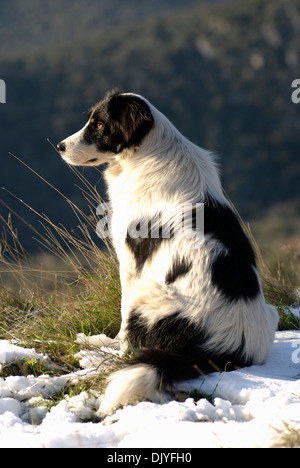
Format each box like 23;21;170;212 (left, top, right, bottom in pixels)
204;199;260;301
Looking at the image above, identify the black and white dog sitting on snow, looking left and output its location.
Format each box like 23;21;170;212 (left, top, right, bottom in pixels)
58;92;278;413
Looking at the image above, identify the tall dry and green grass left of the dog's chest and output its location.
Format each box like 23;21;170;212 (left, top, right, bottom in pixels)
0;161;121;369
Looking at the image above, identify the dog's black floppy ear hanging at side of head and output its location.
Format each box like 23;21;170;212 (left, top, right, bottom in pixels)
108;93;154;152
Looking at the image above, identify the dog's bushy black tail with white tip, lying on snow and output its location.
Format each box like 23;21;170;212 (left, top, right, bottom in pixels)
99;349;209;415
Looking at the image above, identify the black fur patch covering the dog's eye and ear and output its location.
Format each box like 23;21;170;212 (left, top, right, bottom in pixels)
83;92;154;154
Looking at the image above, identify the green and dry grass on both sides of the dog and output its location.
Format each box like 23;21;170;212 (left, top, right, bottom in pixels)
0;165;300;446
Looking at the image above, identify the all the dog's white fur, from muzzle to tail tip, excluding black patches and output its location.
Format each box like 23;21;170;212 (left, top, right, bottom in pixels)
58;91;278;413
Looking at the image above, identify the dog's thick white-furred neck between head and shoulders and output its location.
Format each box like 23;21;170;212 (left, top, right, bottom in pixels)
105;108;227;208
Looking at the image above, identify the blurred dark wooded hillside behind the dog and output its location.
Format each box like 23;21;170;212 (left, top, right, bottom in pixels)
0;0;300;278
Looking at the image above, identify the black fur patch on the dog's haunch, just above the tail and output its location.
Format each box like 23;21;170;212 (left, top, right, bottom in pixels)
127;310;251;383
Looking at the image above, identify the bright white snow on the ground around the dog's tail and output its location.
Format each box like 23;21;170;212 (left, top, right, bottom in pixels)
0;326;300;449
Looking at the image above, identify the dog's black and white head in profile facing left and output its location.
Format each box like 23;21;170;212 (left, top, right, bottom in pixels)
57;92;154;166
